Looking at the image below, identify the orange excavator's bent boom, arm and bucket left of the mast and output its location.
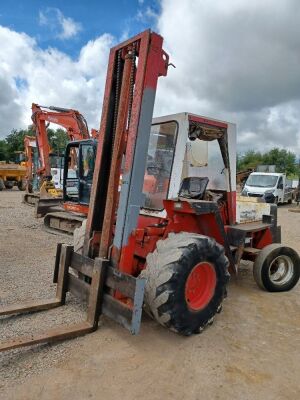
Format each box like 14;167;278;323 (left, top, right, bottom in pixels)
23;103;97;217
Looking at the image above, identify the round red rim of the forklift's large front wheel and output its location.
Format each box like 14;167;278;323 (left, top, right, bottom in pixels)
185;262;217;311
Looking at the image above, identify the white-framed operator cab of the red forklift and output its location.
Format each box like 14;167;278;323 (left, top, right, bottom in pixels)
141;113;236;223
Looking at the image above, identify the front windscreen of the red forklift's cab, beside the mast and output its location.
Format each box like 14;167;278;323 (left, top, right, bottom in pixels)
143;121;178;210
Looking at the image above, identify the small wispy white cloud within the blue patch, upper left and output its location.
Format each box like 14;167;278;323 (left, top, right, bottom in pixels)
39;7;82;40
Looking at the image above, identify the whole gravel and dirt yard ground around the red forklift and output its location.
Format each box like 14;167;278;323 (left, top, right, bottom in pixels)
0;191;300;400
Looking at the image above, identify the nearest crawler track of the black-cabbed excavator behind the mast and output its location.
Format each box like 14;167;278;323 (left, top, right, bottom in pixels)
44;211;86;235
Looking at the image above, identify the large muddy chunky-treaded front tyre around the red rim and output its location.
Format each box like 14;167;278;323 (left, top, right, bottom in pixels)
141;232;229;336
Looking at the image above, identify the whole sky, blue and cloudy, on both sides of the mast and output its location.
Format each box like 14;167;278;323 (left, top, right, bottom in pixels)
0;0;300;157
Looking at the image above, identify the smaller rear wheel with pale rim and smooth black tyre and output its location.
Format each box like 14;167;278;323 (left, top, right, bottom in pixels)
253;243;300;292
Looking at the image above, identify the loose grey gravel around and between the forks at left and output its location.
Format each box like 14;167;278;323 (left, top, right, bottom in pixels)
0;190;85;388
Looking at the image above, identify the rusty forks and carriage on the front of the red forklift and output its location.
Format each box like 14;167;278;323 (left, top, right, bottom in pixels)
0;243;145;352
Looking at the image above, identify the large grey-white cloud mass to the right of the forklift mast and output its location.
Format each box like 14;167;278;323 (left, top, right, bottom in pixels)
156;0;300;154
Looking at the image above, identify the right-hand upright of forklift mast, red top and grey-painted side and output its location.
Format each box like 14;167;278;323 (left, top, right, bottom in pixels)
112;33;168;272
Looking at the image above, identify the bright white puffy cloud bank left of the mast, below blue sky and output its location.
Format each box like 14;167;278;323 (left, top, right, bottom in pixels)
0;26;113;137
